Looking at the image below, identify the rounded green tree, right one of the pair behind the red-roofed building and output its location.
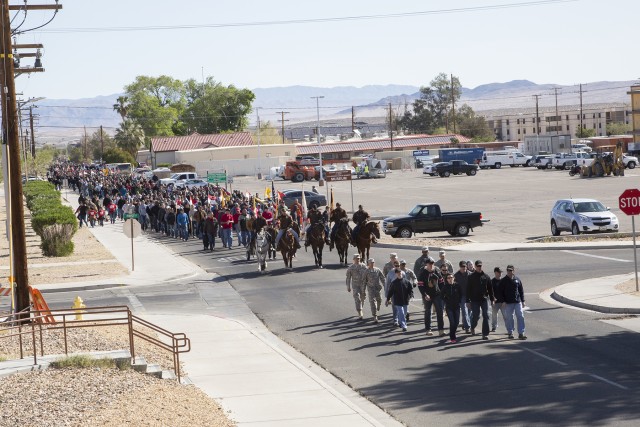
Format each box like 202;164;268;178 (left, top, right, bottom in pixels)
181;77;255;134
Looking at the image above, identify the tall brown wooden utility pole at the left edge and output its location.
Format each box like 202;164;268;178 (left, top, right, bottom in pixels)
0;0;29;317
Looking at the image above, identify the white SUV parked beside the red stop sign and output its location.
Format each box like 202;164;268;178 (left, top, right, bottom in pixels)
550;199;619;236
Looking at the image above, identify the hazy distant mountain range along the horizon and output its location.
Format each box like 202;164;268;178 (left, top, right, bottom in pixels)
33;80;635;143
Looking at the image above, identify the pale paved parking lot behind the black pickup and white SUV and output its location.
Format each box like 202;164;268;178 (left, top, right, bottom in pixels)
228;168;640;243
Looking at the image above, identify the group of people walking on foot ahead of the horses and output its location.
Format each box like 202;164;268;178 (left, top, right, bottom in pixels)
346;246;527;343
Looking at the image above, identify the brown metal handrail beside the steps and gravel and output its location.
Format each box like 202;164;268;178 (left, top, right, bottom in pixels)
0;306;191;382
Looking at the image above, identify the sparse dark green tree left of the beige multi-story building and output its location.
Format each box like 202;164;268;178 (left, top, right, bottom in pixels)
400;73;462;133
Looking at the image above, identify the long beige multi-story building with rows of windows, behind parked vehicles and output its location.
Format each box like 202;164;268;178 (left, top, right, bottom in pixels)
478;103;631;141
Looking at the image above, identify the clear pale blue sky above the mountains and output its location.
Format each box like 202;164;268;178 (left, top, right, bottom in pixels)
11;0;640;99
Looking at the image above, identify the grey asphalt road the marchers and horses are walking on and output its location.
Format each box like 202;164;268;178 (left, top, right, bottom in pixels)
35;237;640;426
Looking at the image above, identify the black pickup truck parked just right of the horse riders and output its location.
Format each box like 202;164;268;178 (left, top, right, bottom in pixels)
382;203;488;238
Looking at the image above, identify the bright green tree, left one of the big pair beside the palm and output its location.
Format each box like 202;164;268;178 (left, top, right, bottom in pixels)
125;76;186;137
